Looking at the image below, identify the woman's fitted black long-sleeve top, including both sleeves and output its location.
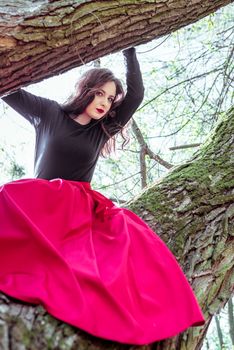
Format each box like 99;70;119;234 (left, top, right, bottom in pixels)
3;48;144;182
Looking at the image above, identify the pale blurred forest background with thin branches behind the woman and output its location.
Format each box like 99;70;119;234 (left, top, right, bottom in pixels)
0;4;234;350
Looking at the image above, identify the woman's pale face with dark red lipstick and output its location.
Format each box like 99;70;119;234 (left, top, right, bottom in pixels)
82;81;116;120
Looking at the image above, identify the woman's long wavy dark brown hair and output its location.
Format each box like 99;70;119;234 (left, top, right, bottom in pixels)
62;68;128;156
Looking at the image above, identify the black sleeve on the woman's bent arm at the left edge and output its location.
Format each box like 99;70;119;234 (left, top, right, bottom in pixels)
2;89;57;127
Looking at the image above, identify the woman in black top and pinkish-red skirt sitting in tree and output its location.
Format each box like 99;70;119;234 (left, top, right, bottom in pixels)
0;48;204;344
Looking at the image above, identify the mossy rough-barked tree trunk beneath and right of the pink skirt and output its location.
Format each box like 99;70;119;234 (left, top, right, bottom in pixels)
0;109;234;350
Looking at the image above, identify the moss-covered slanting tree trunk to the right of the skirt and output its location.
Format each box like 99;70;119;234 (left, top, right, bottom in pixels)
129;109;234;350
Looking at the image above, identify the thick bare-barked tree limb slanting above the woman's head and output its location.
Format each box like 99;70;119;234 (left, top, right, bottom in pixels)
0;0;233;95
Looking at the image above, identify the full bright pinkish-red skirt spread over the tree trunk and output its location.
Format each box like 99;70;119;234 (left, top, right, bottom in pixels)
0;179;204;344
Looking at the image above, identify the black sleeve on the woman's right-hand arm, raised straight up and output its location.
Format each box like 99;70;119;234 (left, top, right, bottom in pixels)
104;47;144;135
